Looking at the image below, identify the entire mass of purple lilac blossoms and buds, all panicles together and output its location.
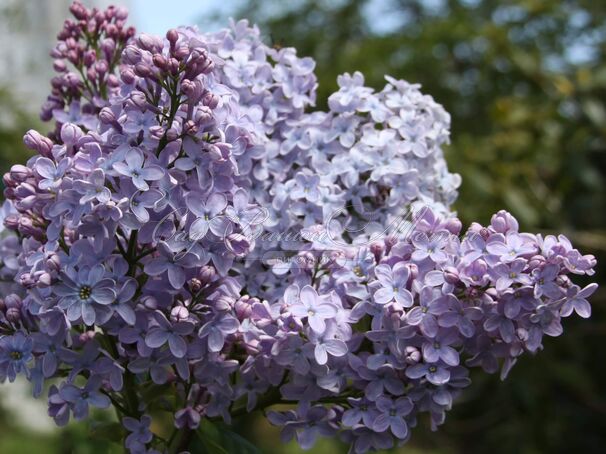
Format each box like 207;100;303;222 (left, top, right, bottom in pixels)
0;2;596;453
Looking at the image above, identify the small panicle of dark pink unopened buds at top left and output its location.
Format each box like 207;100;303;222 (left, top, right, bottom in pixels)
40;1;135;135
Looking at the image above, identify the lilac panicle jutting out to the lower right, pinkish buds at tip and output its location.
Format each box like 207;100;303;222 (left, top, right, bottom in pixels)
269;209;597;453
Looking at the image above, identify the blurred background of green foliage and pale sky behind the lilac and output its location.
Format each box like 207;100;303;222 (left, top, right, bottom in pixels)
0;0;606;454
